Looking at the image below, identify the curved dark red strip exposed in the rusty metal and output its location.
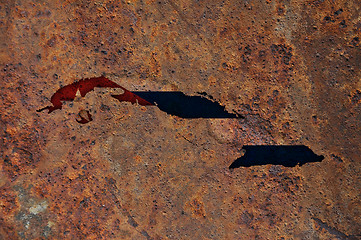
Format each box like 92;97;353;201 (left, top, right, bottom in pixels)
37;76;154;115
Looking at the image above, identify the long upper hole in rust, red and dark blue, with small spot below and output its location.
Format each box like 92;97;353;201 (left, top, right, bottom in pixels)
37;76;243;121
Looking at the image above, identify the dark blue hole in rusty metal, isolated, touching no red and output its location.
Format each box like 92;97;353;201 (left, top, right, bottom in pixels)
229;145;324;169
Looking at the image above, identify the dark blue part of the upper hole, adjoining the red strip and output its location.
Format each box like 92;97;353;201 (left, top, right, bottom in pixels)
133;91;243;118
